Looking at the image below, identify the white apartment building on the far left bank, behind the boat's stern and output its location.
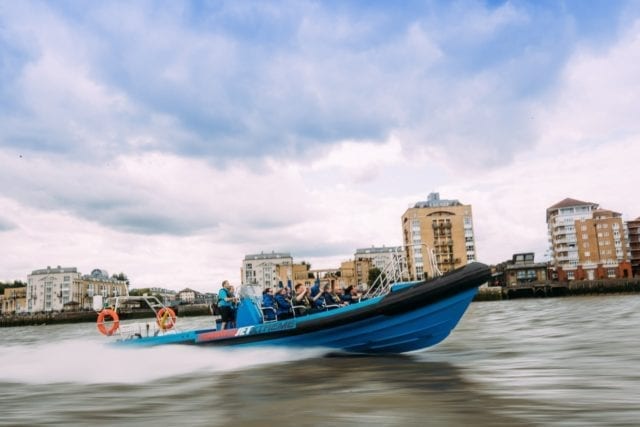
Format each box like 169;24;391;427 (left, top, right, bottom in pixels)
27;266;80;313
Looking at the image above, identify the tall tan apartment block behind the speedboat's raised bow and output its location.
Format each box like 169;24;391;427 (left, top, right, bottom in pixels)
402;193;476;279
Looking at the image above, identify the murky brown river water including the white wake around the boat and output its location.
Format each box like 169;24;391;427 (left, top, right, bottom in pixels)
0;295;640;426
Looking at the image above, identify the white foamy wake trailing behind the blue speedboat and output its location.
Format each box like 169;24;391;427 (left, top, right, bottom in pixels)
0;340;329;384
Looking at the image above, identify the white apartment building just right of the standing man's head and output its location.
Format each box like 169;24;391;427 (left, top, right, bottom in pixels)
241;251;293;289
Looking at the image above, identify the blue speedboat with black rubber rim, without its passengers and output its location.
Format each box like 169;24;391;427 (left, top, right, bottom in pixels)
105;263;490;353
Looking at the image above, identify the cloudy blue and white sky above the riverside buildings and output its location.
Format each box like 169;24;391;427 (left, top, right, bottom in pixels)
0;0;640;292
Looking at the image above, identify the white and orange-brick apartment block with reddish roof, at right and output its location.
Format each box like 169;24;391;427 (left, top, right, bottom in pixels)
547;198;631;281
